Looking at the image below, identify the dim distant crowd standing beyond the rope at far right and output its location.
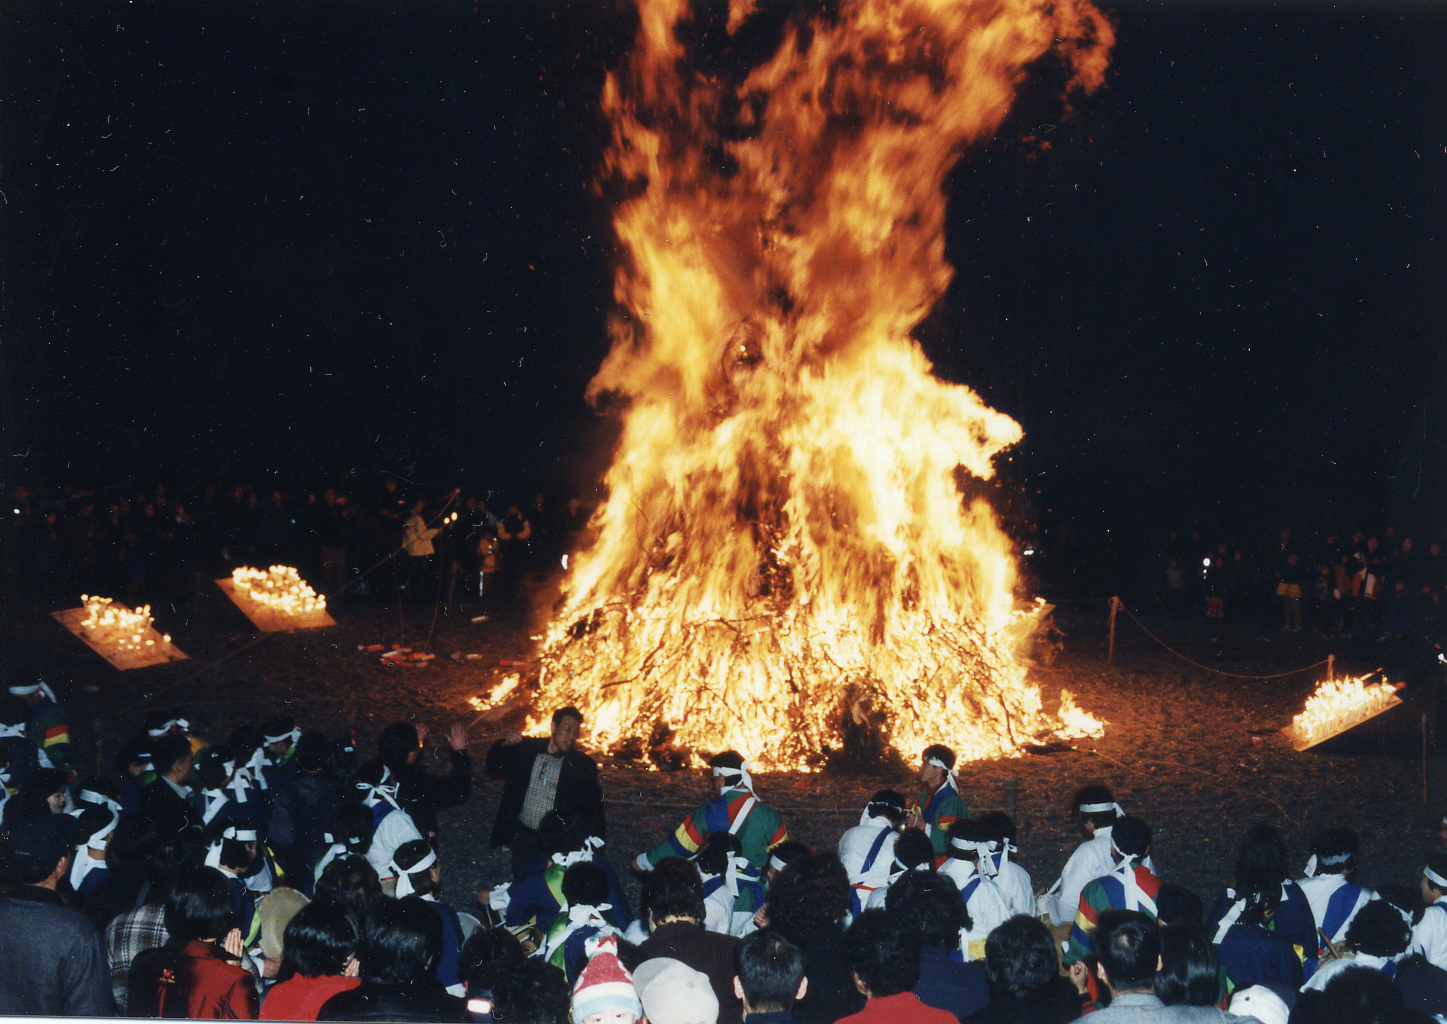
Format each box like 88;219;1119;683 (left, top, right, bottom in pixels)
1140;526;1447;636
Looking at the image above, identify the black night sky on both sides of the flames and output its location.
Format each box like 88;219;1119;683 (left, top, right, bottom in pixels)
0;0;1447;555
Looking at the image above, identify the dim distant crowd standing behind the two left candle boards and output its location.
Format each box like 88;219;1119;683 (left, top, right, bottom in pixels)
4;476;589;605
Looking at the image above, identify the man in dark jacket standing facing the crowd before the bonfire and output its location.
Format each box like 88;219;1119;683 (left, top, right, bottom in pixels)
488;707;608;878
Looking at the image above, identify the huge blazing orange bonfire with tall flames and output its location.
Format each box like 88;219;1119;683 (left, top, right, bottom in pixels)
535;0;1111;767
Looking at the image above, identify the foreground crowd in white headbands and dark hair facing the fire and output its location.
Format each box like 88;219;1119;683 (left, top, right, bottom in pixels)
0;688;1447;1024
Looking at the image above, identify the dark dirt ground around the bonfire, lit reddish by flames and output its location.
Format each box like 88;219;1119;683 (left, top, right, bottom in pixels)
6;589;1447;910
